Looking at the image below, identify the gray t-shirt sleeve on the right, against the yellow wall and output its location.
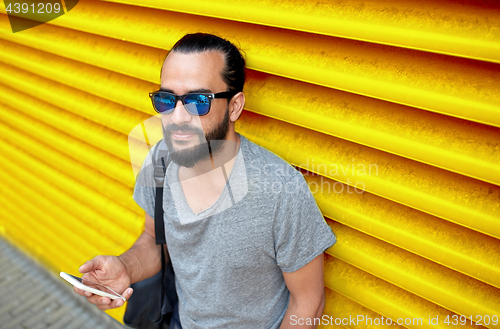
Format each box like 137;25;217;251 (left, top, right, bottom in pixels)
273;175;336;272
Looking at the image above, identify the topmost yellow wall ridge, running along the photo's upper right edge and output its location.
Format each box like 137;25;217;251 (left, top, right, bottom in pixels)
96;0;500;63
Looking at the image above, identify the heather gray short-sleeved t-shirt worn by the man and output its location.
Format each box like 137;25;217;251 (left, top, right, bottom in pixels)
134;136;336;328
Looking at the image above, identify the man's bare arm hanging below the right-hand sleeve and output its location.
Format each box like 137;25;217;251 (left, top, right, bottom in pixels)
280;253;325;329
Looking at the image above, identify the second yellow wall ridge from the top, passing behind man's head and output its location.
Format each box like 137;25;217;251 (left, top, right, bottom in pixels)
0;1;500;126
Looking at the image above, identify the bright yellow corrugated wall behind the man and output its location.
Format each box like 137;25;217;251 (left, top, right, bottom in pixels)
0;0;500;328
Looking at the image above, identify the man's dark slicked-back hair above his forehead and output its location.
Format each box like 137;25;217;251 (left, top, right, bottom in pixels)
170;33;245;92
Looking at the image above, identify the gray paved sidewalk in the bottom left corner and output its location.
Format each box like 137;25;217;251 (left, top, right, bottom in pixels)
0;238;127;329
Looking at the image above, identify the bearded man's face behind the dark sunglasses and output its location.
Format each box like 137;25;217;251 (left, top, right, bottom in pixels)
161;52;229;168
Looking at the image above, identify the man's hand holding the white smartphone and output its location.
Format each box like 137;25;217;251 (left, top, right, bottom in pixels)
73;256;133;311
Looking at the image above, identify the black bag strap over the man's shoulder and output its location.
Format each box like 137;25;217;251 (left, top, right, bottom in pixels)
152;140;170;244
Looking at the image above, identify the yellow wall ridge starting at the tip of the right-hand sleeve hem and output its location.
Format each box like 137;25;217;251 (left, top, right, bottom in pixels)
327;221;500;318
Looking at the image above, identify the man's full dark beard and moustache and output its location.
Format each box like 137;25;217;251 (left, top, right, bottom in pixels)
163;107;229;168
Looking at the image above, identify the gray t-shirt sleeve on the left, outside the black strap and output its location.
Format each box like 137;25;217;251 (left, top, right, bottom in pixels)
133;148;156;218
